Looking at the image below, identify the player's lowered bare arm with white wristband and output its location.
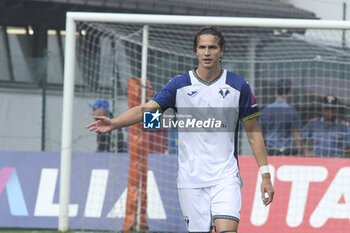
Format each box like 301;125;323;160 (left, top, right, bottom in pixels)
243;117;274;206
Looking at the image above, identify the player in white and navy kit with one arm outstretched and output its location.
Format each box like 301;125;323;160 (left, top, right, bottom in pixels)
87;27;274;232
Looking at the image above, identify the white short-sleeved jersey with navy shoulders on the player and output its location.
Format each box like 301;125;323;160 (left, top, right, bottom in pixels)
151;69;260;188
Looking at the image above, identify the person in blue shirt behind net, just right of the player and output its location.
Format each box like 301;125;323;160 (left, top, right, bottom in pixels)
259;79;302;156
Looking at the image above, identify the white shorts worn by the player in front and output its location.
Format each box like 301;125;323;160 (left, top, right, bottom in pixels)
178;180;242;232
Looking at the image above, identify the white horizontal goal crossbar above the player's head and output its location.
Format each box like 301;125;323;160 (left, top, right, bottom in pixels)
67;12;350;29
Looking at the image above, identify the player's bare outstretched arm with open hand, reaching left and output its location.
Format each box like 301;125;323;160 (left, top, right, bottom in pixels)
86;102;157;133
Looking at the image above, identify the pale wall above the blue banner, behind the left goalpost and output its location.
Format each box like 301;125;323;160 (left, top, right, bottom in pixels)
0;90;127;152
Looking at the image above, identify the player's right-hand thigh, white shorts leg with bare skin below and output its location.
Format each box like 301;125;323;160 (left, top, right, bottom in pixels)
211;182;242;232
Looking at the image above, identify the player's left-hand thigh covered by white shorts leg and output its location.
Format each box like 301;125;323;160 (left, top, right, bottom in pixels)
178;188;211;232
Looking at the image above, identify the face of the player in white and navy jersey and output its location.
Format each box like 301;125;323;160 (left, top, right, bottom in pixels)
196;34;224;69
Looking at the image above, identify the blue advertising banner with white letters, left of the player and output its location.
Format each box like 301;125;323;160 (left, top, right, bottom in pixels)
0;151;186;232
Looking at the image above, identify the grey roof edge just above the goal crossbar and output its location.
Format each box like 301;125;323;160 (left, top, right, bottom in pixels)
24;0;317;19
